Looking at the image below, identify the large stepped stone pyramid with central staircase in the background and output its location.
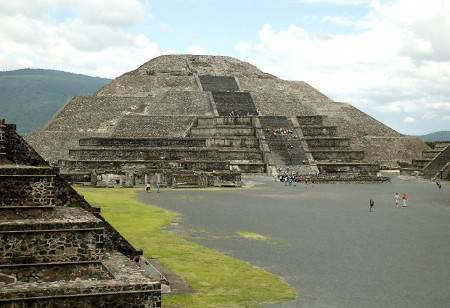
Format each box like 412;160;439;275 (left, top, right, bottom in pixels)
27;55;429;187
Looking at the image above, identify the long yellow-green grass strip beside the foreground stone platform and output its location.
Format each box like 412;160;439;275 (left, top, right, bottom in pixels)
76;187;297;307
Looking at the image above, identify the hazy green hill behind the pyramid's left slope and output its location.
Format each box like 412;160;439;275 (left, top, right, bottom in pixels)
0;69;111;135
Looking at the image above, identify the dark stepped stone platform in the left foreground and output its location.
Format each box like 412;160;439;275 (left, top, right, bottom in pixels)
0;121;161;307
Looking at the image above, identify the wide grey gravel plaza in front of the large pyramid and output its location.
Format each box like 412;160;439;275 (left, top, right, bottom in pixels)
139;176;450;307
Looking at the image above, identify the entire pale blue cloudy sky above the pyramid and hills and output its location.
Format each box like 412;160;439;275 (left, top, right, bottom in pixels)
0;0;450;134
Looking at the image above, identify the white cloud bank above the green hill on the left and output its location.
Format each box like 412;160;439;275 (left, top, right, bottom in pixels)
0;0;167;78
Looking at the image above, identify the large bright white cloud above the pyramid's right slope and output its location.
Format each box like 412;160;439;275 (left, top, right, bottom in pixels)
236;0;450;134
